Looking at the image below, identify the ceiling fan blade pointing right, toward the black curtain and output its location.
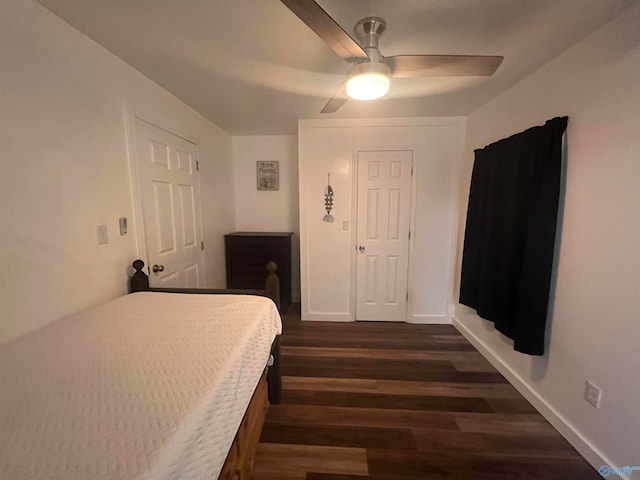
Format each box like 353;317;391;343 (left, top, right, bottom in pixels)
384;55;504;77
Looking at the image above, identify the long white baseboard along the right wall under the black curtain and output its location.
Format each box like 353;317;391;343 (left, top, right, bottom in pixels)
452;317;630;480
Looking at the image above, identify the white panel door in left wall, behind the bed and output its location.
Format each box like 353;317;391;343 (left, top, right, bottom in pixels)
135;119;204;287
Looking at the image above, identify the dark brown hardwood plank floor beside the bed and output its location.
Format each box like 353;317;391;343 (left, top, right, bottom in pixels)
252;305;601;480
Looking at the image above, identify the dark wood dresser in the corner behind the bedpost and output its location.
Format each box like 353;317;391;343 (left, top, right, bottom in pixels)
224;232;293;314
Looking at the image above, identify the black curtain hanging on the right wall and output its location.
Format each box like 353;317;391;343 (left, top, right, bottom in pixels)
460;117;567;355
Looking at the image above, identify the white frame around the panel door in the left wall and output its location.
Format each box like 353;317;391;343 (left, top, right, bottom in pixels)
124;107;206;279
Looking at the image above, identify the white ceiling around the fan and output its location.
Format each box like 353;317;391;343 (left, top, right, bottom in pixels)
39;0;633;135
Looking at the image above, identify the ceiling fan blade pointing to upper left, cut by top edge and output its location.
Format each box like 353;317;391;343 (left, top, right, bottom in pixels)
280;0;368;62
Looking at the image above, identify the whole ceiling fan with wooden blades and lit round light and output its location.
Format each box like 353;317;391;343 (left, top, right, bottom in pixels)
281;0;503;113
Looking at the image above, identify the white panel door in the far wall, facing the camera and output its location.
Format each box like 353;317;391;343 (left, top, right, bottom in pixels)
356;151;413;322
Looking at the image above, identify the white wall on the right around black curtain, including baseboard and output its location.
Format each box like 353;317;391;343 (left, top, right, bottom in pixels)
455;7;640;468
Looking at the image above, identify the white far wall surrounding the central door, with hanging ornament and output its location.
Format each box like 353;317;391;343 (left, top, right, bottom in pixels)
299;118;464;323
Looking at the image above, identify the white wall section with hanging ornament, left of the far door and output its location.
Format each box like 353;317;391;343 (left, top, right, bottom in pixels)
298;125;353;321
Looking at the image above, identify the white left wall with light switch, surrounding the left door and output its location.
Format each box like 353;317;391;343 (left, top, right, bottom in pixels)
0;0;234;342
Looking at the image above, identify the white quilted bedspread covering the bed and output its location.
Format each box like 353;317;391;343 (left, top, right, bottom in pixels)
0;292;281;480
